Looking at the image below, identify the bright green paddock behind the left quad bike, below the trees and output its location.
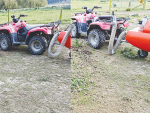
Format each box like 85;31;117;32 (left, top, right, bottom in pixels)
0;9;71;26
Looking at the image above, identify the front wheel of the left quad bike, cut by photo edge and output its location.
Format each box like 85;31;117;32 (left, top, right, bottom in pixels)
0;34;12;51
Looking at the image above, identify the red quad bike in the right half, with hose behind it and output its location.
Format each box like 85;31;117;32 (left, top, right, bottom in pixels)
71;6;129;49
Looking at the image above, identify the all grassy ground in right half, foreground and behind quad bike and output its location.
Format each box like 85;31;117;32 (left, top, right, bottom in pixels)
71;0;150;113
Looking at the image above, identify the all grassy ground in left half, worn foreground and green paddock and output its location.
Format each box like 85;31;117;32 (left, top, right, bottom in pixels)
0;9;71;113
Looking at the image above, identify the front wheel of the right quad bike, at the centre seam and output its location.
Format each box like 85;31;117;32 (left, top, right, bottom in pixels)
71;22;79;38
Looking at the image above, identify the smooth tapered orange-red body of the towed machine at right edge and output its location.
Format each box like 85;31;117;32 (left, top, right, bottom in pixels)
126;28;150;52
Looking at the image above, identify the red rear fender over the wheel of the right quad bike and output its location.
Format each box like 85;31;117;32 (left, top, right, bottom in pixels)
89;22;111;30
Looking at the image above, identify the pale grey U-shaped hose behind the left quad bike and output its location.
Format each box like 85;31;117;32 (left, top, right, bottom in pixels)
48;27;71;58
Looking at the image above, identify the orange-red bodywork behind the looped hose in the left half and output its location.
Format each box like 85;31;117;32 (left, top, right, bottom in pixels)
58;31;71;49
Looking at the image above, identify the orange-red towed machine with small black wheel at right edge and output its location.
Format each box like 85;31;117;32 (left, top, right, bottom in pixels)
126;16;150;58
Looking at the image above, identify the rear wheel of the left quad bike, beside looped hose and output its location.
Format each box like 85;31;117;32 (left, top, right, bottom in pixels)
28;36;48;55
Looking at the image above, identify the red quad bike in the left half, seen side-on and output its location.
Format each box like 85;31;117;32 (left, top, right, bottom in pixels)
0;15;59;55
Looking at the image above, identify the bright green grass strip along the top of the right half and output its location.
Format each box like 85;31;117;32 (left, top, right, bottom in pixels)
71;0;150;12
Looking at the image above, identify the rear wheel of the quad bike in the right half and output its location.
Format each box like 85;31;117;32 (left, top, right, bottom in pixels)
88;29;105;49
